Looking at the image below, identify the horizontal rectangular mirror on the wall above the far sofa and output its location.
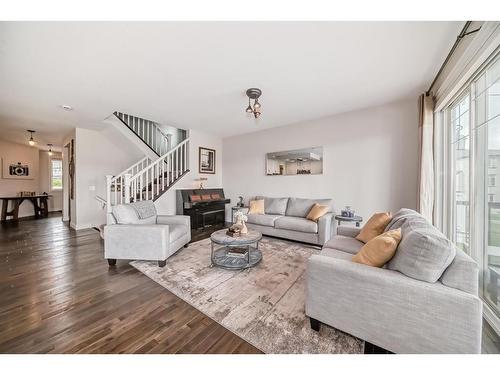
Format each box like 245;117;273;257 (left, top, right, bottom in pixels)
266;147;323;176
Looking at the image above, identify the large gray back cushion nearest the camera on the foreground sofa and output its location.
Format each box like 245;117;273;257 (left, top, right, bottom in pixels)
387;219;455;283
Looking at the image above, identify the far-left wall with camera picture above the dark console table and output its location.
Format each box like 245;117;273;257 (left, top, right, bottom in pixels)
0;139;40;217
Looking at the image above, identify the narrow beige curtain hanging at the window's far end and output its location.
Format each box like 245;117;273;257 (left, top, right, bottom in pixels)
417;94;434;223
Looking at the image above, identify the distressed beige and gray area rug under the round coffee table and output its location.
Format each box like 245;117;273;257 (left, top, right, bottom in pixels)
131;237;364;353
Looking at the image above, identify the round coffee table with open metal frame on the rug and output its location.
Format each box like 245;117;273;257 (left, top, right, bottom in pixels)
210;229;262;270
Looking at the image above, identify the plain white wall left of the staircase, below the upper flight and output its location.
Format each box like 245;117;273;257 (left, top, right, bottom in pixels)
71;126;144;229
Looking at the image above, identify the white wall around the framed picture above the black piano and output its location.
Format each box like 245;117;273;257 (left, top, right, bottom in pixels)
155;130;223;215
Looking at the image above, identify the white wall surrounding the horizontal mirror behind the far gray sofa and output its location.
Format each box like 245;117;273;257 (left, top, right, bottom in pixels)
222;98;418;220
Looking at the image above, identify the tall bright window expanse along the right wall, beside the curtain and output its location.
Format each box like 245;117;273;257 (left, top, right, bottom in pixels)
436;55;500;324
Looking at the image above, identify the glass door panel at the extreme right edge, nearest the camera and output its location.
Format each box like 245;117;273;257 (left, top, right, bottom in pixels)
472;55;500;315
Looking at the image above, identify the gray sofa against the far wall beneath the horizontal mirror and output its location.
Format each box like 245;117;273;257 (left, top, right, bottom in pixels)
243;197;336;246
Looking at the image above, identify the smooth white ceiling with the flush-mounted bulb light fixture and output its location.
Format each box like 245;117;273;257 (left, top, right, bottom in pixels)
0;22;463;144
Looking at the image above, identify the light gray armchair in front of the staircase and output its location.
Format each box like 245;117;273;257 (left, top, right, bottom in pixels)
104;201;191;267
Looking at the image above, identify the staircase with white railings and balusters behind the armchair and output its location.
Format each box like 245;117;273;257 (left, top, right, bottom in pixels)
106;112;189;222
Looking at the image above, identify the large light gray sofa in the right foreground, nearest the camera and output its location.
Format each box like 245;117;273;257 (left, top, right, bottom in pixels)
306;209;482;353
